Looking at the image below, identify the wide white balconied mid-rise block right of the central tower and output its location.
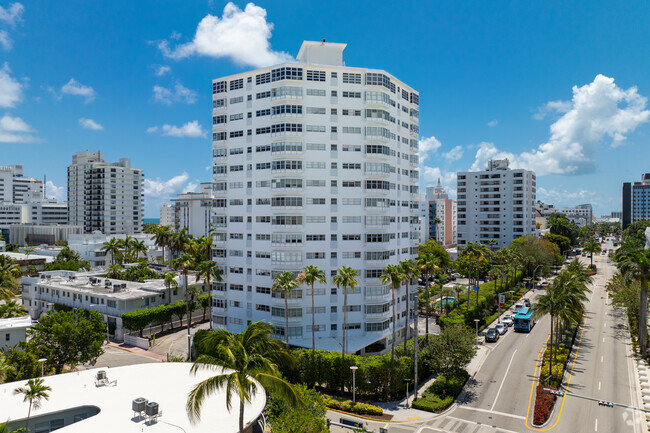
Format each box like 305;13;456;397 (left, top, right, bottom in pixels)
457;159;536;248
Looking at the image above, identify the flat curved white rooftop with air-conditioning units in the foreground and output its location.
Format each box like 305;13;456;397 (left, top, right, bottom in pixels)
0;362;266;433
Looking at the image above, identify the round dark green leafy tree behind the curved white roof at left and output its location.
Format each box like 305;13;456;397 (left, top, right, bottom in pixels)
26;309;106;373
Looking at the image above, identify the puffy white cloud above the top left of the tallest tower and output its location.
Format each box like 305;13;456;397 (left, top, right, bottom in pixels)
158;2;293;68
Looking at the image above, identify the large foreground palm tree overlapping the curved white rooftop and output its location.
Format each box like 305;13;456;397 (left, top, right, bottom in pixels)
185;321;301;433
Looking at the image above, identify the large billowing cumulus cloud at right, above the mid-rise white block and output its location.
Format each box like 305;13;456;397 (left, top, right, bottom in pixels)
472;75;650;175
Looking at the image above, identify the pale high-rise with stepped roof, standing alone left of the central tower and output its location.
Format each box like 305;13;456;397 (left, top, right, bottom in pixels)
68;151;144;235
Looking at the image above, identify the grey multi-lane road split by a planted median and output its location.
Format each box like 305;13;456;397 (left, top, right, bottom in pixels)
380;243;645;433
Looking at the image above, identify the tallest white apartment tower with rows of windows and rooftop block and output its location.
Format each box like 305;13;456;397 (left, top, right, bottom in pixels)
212;41;419;352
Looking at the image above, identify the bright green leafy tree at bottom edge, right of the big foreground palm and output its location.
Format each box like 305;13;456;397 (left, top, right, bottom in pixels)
267;385;329;433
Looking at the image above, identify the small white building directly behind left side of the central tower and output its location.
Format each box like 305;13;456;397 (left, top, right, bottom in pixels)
172;182;218;237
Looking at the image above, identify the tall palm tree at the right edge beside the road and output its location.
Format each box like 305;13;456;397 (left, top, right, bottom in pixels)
616;241;650;359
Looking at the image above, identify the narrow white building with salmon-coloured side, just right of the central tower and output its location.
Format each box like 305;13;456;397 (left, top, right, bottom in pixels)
426;179;458;246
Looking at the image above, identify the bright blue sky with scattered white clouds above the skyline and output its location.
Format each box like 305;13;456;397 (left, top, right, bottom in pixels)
0;0;650;217
